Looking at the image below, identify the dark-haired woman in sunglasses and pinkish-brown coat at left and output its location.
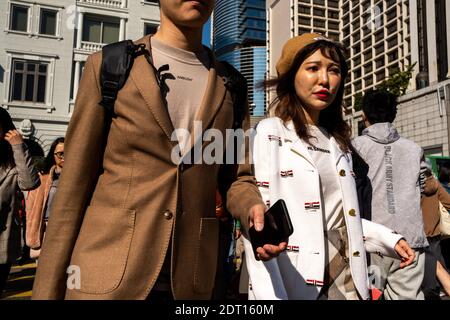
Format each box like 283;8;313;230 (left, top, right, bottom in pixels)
25;137;64;259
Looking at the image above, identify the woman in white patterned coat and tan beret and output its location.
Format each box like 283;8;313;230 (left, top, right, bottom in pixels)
244;34;414;300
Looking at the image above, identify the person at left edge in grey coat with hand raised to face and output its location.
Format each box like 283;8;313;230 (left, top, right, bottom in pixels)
0;108;40;296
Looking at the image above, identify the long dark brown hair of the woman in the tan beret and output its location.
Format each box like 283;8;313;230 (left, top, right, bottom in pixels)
263;40;351;151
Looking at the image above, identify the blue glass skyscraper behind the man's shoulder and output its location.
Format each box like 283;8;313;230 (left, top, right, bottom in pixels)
213;0;267;116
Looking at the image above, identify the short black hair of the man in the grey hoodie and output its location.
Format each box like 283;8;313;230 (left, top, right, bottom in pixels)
362;90;397;124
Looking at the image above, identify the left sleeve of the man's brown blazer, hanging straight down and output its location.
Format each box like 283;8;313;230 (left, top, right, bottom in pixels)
33;53;105;299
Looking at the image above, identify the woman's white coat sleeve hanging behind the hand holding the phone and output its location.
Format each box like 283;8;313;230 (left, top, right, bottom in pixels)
244;121;288;300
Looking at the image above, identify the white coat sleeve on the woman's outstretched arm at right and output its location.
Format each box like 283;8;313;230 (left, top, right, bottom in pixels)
361;219;403;259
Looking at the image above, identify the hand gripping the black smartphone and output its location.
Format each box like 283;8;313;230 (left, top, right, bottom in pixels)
249;204;287;261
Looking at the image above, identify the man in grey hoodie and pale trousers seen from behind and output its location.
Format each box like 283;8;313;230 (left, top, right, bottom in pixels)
353;90;428;300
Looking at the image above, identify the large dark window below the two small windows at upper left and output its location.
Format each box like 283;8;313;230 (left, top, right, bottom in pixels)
10;60;48;103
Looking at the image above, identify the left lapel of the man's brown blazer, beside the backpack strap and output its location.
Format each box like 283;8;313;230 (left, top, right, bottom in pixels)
130;36;176;144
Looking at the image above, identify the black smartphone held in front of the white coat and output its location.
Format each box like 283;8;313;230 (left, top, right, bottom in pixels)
248;199;294;260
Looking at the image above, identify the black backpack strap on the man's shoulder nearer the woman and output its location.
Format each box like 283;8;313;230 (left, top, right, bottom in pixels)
220;61;247;129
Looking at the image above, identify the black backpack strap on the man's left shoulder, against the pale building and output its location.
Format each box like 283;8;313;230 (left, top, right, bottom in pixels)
100;40;145;117
